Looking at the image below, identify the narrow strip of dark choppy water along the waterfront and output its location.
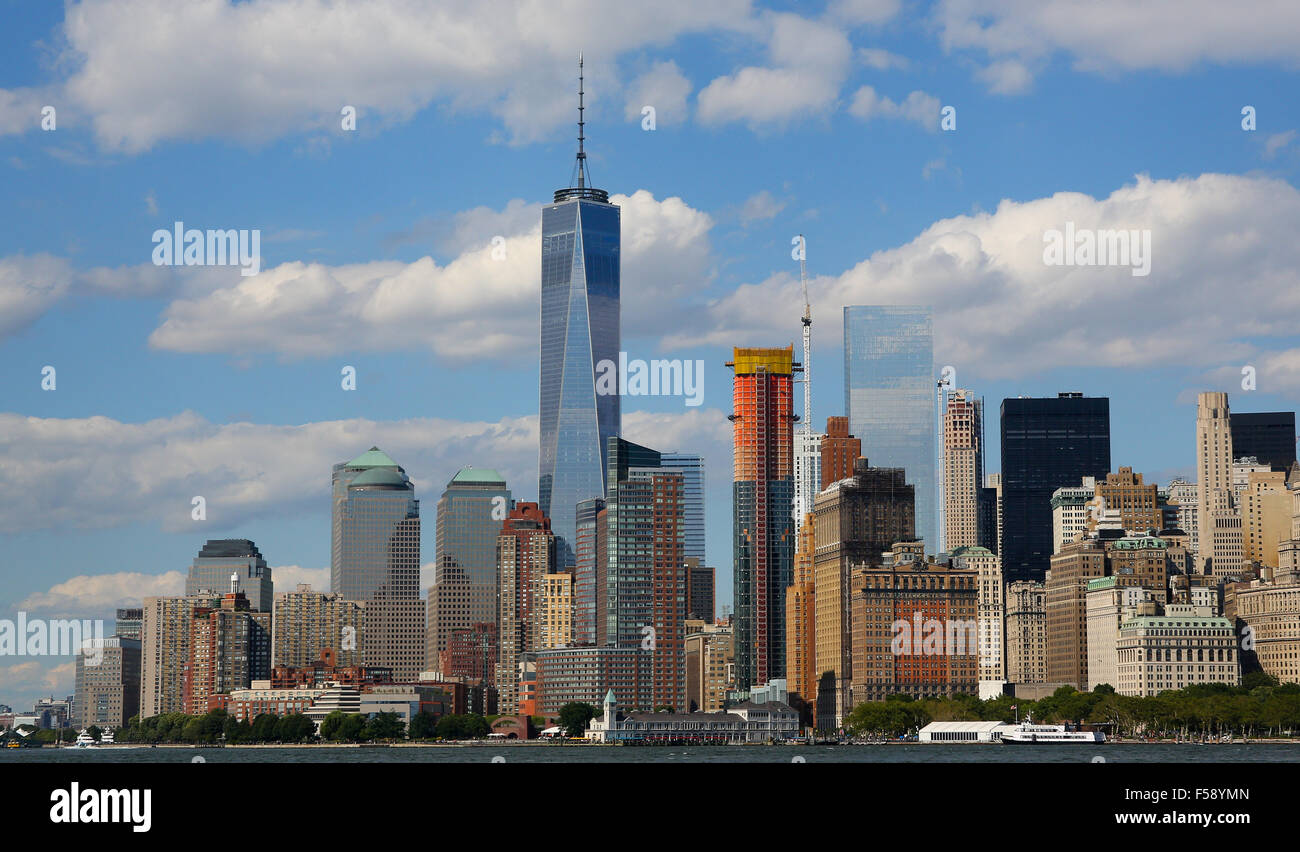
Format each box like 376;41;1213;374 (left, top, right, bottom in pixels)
0;743;1300;764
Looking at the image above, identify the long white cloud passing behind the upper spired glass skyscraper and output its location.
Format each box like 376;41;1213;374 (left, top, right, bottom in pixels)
150;190;712;359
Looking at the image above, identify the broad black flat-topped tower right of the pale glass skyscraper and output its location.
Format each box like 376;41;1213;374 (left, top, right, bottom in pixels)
998;393;1110;581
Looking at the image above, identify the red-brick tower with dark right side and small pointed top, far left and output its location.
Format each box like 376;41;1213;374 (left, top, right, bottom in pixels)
181;590;272;715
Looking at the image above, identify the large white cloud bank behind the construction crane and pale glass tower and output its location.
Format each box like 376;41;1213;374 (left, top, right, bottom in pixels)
668;174;1300;392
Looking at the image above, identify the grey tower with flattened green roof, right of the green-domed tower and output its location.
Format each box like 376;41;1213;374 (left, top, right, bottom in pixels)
428;467;514;666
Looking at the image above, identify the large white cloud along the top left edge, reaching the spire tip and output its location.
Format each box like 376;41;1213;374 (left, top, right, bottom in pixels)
0;0;754;152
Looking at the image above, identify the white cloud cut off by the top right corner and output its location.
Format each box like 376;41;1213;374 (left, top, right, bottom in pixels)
933;0;1300;77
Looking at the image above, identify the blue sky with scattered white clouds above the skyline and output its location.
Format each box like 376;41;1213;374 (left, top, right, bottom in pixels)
0;0;1300;710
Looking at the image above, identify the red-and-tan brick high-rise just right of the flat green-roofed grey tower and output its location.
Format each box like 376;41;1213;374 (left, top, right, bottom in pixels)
493;503;556;715
